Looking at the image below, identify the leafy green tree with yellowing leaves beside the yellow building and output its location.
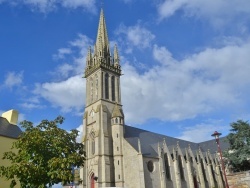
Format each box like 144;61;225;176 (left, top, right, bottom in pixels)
0;116;85;188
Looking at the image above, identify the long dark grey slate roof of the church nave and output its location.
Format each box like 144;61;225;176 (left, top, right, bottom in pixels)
124;125;229;157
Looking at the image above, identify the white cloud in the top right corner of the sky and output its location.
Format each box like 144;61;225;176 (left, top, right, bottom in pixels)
158;0;250;26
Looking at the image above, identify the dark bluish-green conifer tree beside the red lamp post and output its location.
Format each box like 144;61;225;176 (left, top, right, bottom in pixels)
224;120;250;172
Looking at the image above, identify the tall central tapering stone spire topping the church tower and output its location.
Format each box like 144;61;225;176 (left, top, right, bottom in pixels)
95;9;110;58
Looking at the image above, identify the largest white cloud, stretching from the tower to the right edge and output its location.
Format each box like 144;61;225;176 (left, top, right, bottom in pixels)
122;41;250;123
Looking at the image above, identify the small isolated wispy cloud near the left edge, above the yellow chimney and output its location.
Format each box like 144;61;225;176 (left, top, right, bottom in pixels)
4;72;23;89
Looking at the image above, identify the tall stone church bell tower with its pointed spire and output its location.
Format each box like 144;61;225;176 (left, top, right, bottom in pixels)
82;9;124;188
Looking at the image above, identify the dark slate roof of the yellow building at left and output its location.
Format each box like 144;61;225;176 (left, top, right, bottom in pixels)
0;117;22;138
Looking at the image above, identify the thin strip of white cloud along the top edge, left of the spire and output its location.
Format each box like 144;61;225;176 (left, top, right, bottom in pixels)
0;0;96;13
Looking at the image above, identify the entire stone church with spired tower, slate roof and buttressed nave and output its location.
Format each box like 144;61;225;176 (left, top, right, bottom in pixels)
80;10;228;188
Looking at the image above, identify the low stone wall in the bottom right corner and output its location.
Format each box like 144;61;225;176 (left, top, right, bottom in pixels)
227;171;250;188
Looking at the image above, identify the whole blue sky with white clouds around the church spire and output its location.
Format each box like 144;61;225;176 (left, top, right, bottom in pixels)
0;0;250;142
